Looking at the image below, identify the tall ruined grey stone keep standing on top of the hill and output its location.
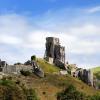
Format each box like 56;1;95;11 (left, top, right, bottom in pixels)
45;37;65;68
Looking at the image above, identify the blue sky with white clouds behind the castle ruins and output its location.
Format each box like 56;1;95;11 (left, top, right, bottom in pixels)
0;0;100;68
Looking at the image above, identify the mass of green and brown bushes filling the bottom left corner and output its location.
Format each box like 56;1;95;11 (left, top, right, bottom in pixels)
0;77;39;100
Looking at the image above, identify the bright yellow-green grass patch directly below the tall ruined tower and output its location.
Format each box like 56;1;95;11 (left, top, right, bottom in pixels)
37;59;60;73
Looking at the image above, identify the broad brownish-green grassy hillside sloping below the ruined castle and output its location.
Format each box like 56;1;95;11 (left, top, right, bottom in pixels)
0;59;100;100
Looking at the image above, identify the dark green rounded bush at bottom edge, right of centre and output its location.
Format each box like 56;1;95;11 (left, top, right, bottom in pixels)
57;85;88;100
